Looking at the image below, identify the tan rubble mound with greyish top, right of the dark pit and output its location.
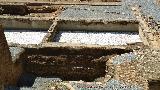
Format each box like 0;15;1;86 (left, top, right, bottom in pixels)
107;52;148;90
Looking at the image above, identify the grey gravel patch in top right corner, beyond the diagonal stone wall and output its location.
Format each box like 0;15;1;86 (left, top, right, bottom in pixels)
123;0;160;30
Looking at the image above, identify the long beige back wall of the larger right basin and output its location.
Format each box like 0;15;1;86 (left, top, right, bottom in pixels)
57;21;138;32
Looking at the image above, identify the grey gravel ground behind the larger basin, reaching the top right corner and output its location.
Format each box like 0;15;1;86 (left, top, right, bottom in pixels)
58;0;160;30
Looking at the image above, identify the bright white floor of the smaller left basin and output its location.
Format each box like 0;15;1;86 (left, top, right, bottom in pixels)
4;30;47;44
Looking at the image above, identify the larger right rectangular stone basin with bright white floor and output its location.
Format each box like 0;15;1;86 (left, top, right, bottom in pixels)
48;21;142;45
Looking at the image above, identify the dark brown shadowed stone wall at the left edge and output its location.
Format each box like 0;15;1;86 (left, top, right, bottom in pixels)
0;26;21;87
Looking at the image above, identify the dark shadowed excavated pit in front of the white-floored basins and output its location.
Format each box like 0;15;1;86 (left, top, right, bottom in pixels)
23;48;132;81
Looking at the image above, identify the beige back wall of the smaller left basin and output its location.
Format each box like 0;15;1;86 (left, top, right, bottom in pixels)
0;17;52;30
